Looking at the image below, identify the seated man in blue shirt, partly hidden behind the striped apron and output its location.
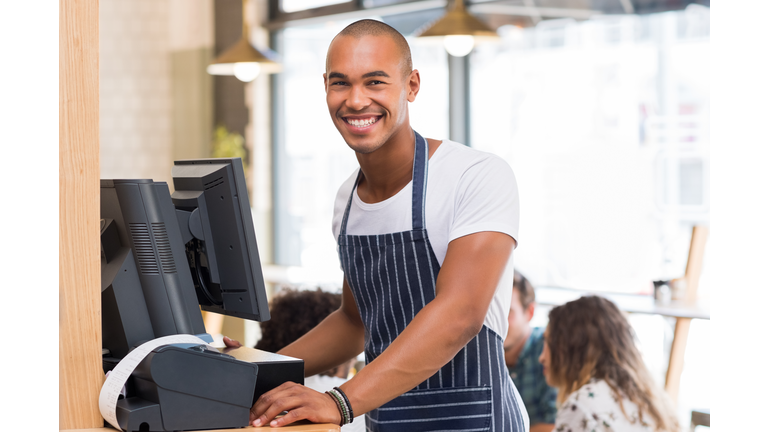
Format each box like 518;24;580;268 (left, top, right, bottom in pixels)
504;271;557;432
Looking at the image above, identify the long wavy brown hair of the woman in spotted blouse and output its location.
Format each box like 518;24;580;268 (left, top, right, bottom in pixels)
545;296;679;431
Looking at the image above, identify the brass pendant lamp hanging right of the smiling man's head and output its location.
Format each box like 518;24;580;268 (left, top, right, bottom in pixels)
415;0;499;57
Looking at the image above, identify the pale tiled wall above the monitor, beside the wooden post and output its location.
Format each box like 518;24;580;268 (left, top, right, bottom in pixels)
99;0;173;186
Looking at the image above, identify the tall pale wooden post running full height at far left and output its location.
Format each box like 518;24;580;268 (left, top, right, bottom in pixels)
59;0;104;429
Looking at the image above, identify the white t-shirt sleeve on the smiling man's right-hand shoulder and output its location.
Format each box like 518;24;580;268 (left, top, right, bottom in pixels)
448;155;520;248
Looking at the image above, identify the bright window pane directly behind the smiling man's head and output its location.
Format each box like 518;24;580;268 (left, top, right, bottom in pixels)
275;21;448;286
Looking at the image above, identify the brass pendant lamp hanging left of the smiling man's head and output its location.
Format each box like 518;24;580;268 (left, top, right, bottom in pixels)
206;0;281;82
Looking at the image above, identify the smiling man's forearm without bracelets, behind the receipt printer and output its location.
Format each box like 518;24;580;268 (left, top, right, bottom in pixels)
278;309;365;376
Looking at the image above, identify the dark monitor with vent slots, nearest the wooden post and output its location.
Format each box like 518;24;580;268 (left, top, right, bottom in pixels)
101;179;212;358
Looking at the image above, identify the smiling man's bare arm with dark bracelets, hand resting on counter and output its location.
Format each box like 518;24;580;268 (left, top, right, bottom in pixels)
251;232;515;426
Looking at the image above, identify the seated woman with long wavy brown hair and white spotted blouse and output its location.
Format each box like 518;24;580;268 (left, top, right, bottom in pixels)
539;296;680;432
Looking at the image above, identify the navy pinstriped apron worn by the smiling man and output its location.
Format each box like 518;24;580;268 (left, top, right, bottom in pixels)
339;132;528;432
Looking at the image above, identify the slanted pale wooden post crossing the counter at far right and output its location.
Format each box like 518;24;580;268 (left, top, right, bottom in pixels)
665;226;709;402
